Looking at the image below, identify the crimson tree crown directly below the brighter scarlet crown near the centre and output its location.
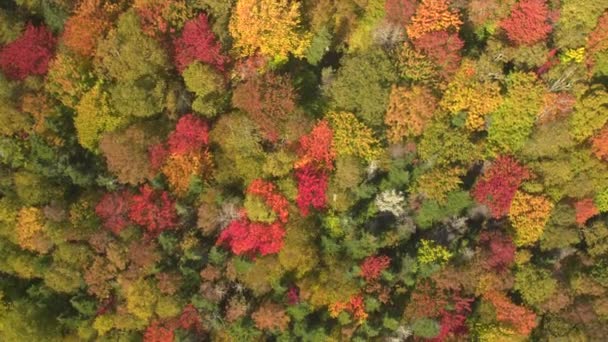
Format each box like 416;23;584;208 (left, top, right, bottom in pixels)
296;166;329;216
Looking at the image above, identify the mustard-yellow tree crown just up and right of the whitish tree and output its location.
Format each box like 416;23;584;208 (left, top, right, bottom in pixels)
416;167;465;204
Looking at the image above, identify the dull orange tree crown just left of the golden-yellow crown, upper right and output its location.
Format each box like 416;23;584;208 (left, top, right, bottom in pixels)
384;86;437;144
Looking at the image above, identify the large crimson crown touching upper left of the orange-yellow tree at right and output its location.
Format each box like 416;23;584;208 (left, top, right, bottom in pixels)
472;156;530;218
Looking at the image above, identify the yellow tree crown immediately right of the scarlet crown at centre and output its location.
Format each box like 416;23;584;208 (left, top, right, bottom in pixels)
327;112;382;162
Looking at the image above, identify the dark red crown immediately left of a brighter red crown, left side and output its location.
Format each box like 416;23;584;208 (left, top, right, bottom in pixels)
95;190;131;234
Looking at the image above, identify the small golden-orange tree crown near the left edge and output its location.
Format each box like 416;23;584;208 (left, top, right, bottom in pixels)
16;207;52;253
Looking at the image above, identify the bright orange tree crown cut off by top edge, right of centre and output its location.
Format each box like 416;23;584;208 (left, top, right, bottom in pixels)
407;0;462;40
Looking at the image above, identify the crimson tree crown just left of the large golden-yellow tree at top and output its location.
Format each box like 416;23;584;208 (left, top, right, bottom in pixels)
173;13;228;73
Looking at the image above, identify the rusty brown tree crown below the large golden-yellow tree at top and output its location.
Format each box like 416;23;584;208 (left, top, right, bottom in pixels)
232;73;296;143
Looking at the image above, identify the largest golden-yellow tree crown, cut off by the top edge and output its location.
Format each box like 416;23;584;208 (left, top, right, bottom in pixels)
229;0;310;60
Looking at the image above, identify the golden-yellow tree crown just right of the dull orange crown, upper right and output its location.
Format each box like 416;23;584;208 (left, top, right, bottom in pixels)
439;62;502;131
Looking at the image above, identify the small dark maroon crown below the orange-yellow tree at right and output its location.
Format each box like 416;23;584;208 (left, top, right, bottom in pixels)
479;231;517;271
